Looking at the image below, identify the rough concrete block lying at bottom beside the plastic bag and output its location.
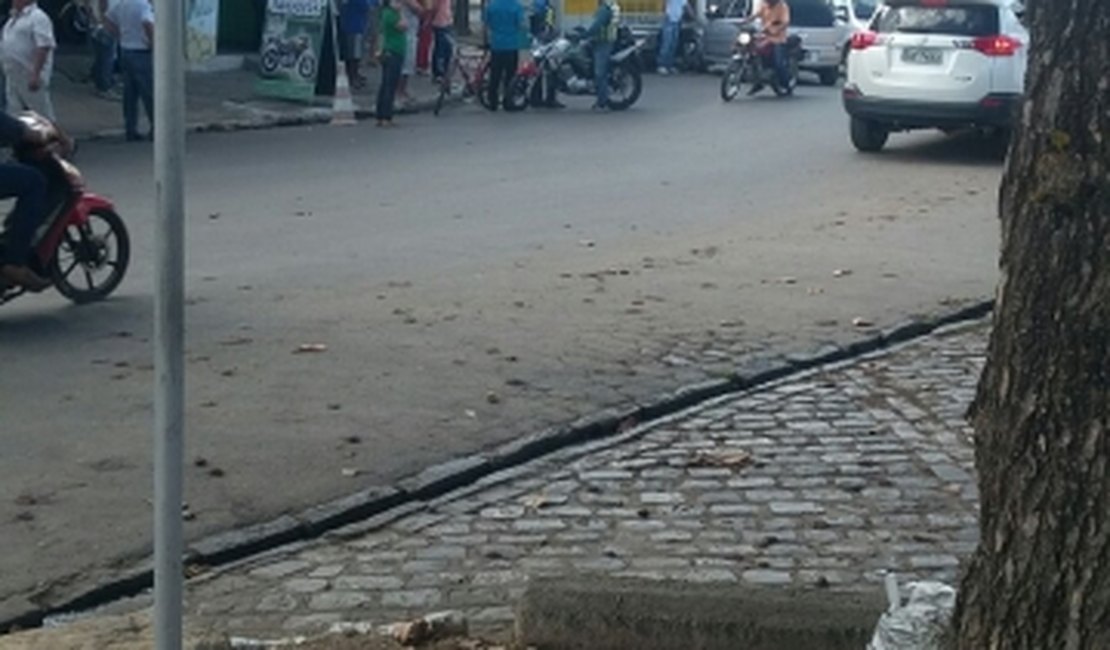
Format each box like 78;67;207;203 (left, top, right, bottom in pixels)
514;575;886;650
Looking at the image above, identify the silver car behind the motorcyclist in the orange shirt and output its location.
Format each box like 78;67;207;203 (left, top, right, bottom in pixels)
705;0;850;85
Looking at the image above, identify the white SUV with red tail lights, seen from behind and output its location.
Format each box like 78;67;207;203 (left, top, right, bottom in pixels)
844;0;1029;152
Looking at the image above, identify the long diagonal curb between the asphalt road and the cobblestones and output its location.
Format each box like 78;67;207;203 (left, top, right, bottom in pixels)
0;301;993;633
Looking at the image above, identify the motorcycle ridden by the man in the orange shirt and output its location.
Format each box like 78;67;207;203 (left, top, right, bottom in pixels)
720;22;806;102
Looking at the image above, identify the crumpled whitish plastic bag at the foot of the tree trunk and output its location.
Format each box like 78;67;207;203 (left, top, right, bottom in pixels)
867;575;956;650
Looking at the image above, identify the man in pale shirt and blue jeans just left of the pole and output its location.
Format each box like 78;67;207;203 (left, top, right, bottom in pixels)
104;0;154;142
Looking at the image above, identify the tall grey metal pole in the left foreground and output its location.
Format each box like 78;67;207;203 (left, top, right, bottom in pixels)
154;0;185;650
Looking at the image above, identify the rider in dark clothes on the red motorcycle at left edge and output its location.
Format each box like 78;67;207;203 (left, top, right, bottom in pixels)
0;113;50;292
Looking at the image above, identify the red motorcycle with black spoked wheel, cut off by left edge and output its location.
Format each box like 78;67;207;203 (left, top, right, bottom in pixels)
0;113;131;305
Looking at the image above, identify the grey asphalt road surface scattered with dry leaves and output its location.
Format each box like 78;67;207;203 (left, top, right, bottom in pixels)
0;72;1000;618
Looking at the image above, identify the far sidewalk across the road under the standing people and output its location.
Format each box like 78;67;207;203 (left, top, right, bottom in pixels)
51;54;446;139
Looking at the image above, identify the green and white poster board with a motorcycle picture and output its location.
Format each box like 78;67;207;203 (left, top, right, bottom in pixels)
255;0;331;102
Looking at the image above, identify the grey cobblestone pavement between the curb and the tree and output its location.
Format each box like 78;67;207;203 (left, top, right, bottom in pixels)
166;322;988;636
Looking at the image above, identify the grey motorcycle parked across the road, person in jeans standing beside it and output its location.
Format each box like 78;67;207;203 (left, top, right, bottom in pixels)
505;26;644;111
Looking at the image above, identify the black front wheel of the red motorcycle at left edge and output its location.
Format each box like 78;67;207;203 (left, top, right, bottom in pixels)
48;209;131;305
